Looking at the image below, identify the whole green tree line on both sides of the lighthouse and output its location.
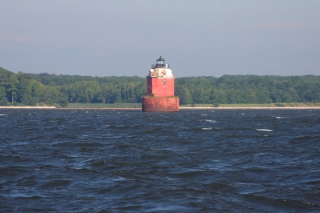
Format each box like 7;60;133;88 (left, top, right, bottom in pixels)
0;68;320;106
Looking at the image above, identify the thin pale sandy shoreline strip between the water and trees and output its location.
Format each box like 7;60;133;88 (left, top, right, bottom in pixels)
0;106;320;111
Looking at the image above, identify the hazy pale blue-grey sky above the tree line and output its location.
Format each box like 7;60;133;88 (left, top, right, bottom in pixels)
0;0;320;77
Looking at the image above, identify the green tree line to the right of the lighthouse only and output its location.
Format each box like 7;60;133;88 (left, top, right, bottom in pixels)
175;75;320;104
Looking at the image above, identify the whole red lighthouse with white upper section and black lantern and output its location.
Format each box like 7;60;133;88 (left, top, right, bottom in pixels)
142;56;179;112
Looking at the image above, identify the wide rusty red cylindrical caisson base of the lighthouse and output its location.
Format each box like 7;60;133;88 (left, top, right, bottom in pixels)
142;97;179;112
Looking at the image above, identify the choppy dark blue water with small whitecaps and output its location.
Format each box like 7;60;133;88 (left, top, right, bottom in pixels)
0;110;320;212
